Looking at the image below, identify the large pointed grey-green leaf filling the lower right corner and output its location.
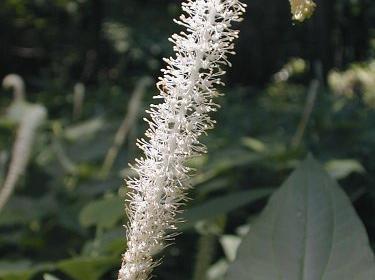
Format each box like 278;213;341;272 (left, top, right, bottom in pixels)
227;157;375;280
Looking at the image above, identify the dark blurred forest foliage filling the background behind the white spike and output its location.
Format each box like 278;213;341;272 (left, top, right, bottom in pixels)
0;0;375;280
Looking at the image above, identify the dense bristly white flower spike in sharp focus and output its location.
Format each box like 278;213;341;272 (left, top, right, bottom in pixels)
118;0;245;280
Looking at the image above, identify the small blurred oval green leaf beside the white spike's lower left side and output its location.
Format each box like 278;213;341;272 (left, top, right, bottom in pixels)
79;196;124;228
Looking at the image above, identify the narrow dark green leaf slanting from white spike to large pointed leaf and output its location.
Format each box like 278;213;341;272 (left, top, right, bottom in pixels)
182;189;272;229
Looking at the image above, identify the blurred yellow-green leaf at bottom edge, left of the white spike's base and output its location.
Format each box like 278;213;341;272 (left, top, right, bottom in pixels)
57;257;118;280
